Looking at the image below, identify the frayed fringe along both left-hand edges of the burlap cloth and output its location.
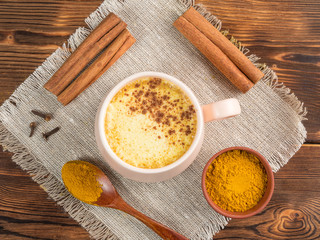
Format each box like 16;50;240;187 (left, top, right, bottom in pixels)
0;1;121;240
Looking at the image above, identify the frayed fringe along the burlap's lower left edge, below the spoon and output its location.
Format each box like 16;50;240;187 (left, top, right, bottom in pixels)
0;123;117;240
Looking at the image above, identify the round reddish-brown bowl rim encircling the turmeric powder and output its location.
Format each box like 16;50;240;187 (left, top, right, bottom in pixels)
201;147;274;218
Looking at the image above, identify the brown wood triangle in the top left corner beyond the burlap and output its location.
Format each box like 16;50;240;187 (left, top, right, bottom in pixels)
0;0;101;104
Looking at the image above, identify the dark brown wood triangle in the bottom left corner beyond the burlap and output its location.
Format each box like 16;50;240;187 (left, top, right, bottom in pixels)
0;147;89;240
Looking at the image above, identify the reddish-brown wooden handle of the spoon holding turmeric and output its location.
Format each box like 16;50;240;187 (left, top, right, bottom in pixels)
111;197;188;240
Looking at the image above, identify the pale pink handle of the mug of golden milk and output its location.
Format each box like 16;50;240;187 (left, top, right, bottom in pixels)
202;98;241;122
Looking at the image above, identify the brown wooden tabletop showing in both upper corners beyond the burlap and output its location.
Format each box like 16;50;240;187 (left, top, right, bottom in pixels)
0;0;320;143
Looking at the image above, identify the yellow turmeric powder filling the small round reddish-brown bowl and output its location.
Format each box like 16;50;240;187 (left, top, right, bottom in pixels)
205;150;268;212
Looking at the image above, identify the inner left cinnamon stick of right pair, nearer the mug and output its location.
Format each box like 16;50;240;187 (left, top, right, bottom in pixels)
173;16;253;93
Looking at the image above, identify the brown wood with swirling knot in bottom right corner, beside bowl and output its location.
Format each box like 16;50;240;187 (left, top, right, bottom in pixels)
215;145;320;239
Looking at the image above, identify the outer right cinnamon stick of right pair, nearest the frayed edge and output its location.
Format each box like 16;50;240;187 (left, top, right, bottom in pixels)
182;7;264;83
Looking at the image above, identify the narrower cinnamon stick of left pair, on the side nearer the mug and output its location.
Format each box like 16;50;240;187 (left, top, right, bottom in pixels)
58;29;131;105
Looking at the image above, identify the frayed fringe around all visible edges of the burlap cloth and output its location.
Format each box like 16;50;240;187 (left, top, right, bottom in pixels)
0;0;307;240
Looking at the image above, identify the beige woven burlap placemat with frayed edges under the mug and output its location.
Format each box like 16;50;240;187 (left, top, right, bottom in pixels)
0;0;306;240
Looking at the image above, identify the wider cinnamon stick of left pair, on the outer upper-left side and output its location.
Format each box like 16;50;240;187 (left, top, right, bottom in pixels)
44;13;126;95
